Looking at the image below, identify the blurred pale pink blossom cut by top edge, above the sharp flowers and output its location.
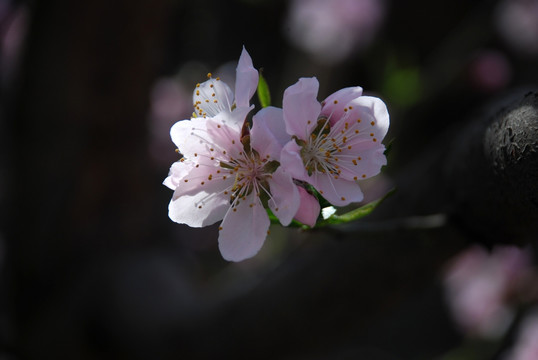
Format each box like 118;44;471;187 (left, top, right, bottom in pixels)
284;0;386;64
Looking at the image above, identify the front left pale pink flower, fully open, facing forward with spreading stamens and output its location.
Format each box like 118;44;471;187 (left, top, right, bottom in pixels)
164;107;300;261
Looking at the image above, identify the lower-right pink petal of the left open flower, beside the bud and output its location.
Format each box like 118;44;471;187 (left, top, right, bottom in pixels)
267;166;300;226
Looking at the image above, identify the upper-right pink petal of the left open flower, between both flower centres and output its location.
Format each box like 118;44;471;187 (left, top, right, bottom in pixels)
250;106;290;161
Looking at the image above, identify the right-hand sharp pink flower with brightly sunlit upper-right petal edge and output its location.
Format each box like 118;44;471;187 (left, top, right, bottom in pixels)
281;78;389;206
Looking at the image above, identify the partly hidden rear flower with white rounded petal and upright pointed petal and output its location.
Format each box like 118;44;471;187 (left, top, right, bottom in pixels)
192;48;258;117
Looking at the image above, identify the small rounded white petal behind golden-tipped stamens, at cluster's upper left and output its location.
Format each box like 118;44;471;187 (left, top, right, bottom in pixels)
192;78;234;117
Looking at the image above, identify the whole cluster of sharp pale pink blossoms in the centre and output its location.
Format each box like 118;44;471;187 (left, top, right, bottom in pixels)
164;49;389;261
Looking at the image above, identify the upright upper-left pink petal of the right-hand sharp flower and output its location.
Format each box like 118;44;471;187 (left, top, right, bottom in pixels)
282;77;321;140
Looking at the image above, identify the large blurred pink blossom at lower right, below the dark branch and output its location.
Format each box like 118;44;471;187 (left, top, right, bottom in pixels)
445;246;531;338
